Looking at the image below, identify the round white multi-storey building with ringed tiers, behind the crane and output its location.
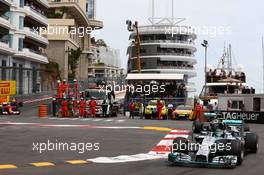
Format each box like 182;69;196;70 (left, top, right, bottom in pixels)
127;23;197;92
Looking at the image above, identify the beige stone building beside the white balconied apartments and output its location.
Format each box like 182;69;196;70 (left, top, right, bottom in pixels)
45;0;103;81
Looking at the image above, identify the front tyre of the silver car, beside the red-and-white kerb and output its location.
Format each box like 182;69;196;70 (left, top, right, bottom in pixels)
172;137;189;154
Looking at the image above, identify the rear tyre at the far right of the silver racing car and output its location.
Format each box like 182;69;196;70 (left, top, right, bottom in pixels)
245;133;258;153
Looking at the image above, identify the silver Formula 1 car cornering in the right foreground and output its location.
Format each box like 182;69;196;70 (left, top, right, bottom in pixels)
168;119;258;168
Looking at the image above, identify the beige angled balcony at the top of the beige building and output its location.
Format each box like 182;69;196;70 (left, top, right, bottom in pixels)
49;0;90;27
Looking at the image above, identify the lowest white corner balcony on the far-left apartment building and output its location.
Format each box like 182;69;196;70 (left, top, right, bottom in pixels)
14;48;49;64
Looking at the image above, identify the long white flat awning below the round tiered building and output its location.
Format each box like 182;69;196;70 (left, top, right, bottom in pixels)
126;73;183;80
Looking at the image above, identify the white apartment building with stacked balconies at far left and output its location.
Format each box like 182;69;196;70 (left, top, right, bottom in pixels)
0;0;49;94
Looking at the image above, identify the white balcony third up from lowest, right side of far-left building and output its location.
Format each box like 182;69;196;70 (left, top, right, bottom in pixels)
24;5;48;26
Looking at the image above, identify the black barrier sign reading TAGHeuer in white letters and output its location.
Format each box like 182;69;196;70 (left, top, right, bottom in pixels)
220;111;264;124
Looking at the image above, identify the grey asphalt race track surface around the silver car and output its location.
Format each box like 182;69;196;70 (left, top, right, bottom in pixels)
0;105;264;175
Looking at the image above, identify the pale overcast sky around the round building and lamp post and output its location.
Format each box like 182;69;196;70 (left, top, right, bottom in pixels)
94;0;264;94
